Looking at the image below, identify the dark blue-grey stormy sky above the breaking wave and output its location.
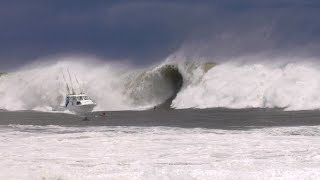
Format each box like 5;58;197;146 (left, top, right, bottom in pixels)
0;0;320;70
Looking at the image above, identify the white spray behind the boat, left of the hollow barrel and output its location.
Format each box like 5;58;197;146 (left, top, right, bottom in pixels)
0;57;135;111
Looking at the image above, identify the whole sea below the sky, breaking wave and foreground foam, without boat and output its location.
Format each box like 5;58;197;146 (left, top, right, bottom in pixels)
0;56;320;180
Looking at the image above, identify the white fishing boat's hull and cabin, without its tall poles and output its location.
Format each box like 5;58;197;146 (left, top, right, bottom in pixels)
65;93;96;113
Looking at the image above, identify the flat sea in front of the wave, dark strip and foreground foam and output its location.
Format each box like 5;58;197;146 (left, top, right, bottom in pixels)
0;108;320;180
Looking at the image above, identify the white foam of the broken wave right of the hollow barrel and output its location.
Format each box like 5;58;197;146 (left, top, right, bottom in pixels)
172;61;320;110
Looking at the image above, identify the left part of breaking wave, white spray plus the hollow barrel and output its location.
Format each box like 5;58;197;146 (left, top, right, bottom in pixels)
0;57;210;111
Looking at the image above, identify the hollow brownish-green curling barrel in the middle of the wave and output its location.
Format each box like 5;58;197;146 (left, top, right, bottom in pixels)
125;65;183;107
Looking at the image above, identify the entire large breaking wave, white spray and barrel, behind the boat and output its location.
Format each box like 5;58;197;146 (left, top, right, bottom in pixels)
0;55;320;111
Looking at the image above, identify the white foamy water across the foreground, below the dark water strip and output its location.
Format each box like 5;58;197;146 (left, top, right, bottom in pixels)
0;126;320;180
